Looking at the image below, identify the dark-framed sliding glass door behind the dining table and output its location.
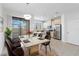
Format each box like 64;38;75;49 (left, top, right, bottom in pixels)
12;17;30;38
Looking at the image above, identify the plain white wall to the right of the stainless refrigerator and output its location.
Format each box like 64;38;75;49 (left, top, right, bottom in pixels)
63;9;79;45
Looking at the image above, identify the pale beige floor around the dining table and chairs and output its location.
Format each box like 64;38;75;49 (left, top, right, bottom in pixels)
1;39;79;56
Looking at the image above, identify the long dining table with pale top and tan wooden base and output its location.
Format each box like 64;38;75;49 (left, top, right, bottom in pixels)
20;36;49;55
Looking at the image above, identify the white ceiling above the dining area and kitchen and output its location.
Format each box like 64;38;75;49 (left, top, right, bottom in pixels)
3;3;79;18
